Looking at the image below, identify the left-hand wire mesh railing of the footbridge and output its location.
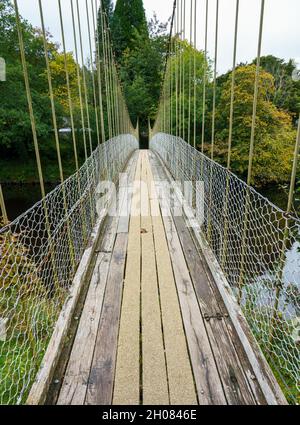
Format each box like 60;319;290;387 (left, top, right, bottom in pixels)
0;134;138;404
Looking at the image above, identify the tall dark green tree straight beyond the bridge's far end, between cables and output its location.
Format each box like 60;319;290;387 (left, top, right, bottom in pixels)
98;0;169;131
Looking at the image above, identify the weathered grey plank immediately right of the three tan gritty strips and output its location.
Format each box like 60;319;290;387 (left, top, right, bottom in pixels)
153;157;227;405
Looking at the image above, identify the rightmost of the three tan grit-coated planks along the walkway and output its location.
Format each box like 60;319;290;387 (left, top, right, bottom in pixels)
147;155;197;405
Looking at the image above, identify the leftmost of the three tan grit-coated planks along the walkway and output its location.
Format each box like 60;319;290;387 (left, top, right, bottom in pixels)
113;152;141;405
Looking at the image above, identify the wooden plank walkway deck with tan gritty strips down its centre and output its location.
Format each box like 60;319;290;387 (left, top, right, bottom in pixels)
57;151;286;405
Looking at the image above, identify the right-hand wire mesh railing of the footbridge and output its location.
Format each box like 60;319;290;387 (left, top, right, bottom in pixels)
150;133;300;403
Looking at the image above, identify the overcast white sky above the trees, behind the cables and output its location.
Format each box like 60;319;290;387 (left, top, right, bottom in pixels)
19;0;300;74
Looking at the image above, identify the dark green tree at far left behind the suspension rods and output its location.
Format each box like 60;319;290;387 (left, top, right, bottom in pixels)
0;0;54;158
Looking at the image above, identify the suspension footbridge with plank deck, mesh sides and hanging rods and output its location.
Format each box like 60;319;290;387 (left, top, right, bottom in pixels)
0;0;300;405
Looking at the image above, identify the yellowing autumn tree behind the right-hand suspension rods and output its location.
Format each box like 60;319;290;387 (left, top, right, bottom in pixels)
216;65;296;186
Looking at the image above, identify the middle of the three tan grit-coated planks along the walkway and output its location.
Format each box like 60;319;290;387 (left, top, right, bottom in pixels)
141;155;170;405
